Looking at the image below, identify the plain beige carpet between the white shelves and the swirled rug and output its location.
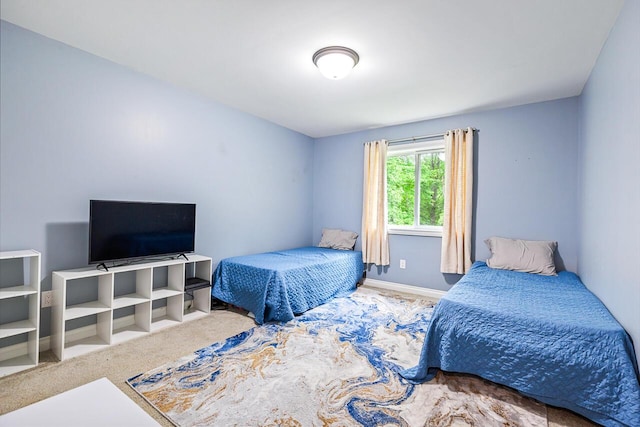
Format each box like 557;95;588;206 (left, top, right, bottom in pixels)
0;288;595;427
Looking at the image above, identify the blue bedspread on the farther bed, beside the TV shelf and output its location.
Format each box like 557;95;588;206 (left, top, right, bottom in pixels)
211;246;364;324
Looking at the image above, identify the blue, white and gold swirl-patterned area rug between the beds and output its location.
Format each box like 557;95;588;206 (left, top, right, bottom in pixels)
127;288;547;427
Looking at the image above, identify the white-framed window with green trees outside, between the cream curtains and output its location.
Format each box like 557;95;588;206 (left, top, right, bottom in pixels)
387;139;445;236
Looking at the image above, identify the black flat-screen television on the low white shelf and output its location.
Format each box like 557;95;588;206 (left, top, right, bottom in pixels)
89;200;196;264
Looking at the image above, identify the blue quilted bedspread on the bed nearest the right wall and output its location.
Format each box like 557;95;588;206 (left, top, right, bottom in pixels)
401;262;640;427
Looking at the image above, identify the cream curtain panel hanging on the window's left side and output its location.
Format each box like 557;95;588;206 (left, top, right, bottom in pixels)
361;140;389;265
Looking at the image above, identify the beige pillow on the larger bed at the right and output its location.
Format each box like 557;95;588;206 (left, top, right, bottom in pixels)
484;237;558;276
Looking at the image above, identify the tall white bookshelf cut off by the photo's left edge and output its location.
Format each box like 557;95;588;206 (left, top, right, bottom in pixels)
0;249;41;377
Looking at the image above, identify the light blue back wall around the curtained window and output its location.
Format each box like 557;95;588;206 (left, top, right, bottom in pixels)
313;98;579;290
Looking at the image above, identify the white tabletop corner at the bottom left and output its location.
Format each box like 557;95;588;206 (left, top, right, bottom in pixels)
0;378;160;427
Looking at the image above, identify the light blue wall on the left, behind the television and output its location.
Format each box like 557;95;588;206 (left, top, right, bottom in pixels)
0;22;313;335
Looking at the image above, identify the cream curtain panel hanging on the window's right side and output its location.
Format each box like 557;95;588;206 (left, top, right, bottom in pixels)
440;128;473;274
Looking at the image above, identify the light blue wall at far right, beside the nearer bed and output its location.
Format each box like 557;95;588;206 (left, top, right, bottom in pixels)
578;0;640;359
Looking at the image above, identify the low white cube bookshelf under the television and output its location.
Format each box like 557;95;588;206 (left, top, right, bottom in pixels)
51;254;212;360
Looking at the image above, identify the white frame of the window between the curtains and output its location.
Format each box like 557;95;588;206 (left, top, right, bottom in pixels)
386;136;447;237
